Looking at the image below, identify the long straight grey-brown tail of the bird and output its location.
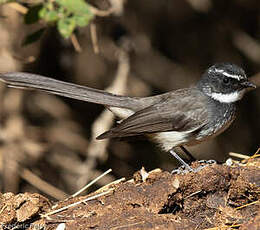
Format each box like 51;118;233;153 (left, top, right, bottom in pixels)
0;72;142;111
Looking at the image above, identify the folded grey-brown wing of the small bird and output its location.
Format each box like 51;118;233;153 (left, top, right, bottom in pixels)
97;89;208;139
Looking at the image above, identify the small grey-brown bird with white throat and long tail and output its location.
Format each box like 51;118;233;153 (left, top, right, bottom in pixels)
0;63;256;171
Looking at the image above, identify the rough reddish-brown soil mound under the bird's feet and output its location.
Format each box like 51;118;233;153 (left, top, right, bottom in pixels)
0;158;260;230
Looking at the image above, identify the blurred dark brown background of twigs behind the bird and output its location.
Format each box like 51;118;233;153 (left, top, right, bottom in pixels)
0;0;260;199
